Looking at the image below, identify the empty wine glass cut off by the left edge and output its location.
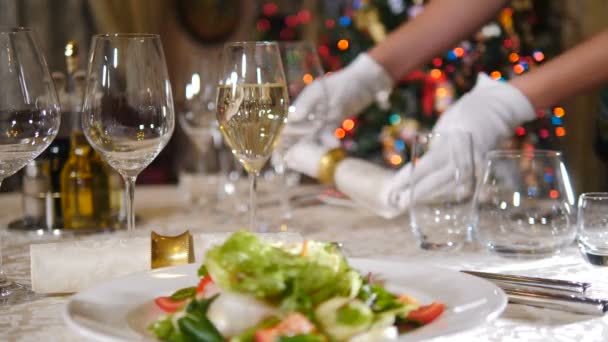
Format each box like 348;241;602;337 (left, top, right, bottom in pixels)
0;28;60;302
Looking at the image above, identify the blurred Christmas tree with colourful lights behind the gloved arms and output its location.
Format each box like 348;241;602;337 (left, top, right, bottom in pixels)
257;0;566;167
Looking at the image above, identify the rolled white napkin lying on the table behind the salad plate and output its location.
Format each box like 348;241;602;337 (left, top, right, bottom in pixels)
30;233;302;294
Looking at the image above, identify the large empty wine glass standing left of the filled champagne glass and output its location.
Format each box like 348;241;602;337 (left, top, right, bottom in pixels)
82;33;175;234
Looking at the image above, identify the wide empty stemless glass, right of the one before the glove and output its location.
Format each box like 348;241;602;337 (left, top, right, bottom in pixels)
474;150;576;258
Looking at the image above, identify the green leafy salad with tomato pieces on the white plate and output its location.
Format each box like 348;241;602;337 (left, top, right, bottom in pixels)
149;232;444;342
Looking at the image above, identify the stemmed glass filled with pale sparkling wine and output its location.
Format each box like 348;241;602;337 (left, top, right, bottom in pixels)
217;42;289;231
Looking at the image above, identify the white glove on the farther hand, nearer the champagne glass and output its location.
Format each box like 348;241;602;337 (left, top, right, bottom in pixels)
288;53;393;125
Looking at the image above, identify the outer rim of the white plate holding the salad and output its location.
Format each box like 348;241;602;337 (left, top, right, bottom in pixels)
62;258;508;342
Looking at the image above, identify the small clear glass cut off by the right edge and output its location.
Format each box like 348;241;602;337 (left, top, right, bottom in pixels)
577;192;608;266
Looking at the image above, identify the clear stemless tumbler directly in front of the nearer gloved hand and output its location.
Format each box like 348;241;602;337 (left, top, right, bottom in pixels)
406;131;475;250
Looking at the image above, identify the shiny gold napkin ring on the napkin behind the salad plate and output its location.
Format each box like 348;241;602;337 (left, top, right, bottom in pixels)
150;231;194;269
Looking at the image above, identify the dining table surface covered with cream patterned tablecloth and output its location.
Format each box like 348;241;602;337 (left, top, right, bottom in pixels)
0;185;608;342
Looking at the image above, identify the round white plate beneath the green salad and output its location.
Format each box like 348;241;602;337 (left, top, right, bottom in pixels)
64;259;507;341
